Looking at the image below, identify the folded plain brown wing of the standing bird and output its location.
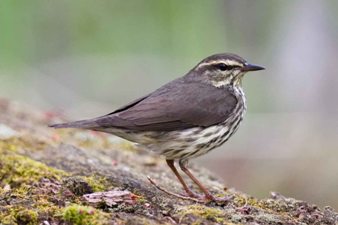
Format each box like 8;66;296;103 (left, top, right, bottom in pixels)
95;80;237;131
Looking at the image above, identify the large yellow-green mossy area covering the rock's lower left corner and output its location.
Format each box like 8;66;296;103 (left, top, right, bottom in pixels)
0;137;114;225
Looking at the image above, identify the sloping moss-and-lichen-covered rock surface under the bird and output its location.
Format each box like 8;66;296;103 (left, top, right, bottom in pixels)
0;99;338;225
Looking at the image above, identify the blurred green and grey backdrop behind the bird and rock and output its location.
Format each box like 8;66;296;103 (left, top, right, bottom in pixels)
0;0;338;209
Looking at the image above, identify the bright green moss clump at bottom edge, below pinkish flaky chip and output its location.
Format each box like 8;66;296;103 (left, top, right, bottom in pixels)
62;204;109;225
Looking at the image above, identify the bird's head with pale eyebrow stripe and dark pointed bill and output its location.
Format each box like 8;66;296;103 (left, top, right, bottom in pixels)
192;53;264;87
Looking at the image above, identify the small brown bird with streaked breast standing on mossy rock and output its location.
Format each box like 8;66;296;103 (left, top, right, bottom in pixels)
50;53;265;202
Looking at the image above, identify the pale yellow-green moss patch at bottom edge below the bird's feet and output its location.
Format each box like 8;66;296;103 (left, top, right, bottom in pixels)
178;205;225;224
